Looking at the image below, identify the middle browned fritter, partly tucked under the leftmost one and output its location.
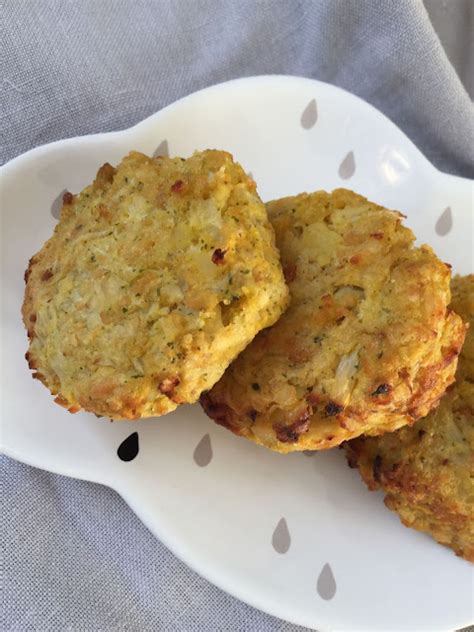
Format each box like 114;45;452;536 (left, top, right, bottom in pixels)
201;189;465;452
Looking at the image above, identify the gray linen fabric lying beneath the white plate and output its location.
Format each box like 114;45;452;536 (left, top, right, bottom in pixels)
0;0;474;632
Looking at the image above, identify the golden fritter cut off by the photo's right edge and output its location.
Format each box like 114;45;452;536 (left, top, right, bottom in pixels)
346;275;474;562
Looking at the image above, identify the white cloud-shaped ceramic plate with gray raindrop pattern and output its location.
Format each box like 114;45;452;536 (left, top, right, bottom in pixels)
1;76;473;630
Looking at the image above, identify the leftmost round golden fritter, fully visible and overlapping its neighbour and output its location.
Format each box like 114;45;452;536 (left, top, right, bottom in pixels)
23;151;288;419
